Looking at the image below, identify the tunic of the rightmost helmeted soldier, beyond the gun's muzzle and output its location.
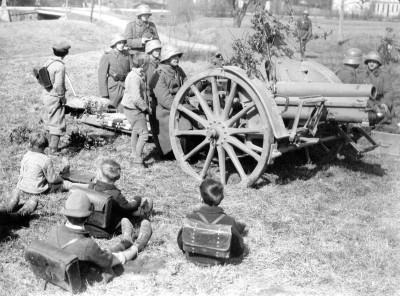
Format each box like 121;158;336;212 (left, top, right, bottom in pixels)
362;67;394;110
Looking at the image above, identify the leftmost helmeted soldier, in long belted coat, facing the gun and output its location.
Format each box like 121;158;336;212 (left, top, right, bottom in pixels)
98;34;132;113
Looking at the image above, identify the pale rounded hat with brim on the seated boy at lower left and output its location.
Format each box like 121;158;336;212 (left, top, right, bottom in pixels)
61;190;92;218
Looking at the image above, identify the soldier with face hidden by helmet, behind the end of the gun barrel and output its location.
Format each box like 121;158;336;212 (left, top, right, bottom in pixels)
336;48;362;84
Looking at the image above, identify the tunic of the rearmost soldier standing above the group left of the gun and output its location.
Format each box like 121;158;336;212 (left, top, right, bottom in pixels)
124;18;160;52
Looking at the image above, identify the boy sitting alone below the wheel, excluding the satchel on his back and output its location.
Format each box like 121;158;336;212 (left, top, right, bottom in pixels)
178;179;246;265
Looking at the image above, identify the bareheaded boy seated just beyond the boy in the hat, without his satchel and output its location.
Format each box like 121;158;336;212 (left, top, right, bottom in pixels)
85;159;153;245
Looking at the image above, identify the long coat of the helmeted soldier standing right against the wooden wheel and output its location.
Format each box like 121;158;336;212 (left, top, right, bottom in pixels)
150;64;190;155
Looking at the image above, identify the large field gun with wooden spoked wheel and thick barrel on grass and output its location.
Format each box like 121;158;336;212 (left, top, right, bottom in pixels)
169;31;384;186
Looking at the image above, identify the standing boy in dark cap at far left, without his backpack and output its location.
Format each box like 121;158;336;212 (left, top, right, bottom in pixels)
41;41;71;155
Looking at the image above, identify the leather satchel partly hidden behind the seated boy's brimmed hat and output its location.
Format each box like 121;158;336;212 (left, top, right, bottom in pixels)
71;187;112;228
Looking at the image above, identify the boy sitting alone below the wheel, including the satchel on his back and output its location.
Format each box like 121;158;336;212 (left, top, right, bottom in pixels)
178;179;246;266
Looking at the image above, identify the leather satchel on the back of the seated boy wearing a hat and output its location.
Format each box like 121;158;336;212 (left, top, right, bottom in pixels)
25;239;81;294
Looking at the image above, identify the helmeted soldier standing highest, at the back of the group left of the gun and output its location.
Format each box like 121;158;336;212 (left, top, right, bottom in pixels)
124;4;160;52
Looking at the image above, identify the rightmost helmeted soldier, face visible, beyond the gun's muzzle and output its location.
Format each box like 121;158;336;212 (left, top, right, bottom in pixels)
362;51;394;119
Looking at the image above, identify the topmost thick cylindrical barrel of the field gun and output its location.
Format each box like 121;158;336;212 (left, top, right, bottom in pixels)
275;82;377;98
